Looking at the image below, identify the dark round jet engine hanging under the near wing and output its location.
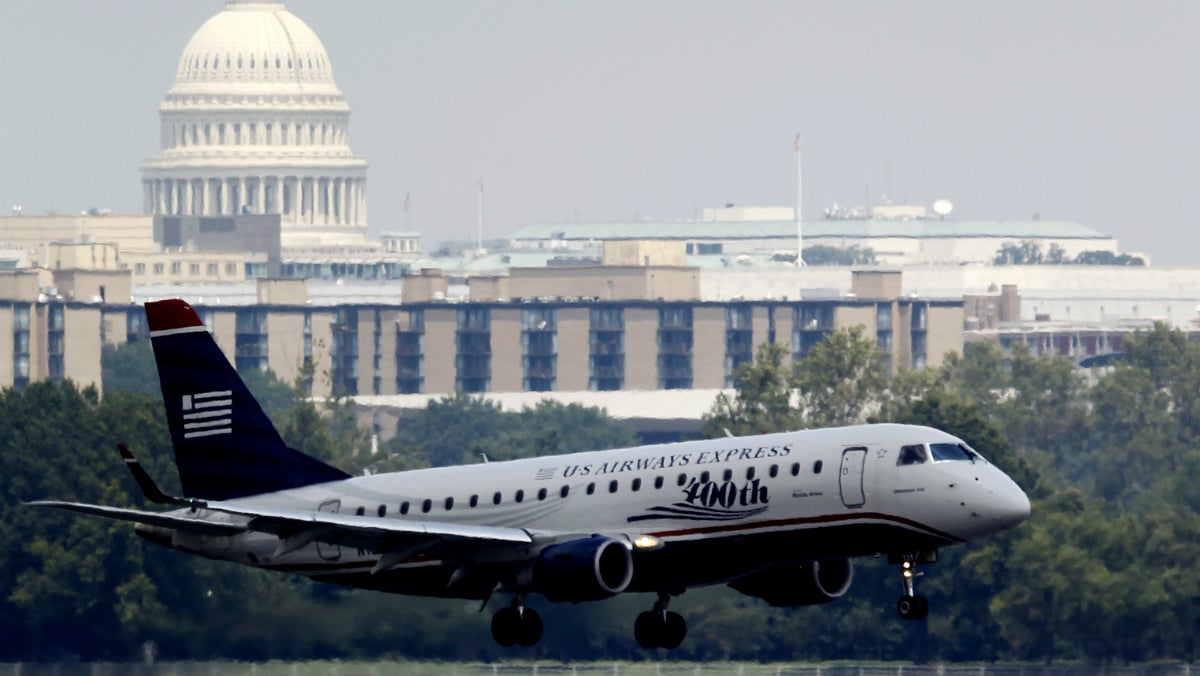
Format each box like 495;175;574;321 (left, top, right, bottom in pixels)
521;536;634;602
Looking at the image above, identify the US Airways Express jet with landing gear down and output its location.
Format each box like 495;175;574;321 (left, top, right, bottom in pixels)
29;299;1030;650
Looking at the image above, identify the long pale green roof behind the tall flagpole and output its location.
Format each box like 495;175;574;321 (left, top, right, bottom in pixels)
506;220;1110;240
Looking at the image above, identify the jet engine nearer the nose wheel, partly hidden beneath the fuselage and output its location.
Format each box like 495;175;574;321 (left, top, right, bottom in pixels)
730;558;854;608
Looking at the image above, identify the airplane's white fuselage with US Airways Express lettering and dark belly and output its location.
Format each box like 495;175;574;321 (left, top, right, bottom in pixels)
159;425;1030;596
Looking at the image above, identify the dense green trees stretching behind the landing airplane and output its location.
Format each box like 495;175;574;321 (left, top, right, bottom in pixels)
7;325;1200;664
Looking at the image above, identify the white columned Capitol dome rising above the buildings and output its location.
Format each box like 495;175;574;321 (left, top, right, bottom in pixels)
142;0;367;246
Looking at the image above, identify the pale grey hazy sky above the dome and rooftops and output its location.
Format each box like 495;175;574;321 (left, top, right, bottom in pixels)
0;0;1200;265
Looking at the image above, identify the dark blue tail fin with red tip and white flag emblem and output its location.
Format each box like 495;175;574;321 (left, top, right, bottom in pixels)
145;299;349;499
